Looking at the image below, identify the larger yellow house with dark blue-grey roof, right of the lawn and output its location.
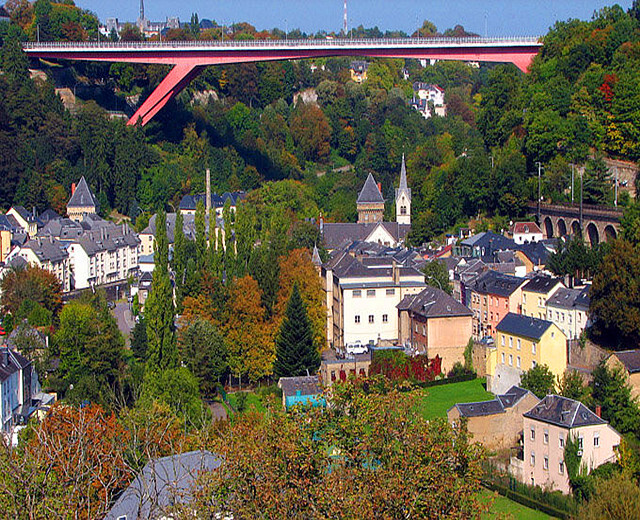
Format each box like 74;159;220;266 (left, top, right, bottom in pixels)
487;312;567;393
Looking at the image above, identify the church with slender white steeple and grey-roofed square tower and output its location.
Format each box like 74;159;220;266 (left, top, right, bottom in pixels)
320;155;411;251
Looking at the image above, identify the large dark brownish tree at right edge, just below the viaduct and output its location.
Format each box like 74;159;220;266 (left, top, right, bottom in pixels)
589;240;640;349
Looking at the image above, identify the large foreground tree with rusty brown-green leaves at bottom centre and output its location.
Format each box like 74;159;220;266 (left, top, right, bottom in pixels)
182;379;489;520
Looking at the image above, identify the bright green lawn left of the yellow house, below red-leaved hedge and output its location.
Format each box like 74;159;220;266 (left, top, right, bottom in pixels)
419;379;493;419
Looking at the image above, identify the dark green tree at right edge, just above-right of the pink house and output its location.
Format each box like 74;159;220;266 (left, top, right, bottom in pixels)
591;362;640;433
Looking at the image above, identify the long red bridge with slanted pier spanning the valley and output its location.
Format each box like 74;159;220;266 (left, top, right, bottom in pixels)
24;37;542;125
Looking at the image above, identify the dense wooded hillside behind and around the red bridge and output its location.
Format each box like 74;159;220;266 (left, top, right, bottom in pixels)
0;0;640;248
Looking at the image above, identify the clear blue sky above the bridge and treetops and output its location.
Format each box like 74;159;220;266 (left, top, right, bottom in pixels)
76;0;632;36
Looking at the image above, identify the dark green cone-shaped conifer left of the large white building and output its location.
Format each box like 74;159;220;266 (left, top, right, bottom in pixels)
273;283;320;377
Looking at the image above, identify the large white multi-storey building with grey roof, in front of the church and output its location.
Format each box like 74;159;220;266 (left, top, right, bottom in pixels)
322;252;426;347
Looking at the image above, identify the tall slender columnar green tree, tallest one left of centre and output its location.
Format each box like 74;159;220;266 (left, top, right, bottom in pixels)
145;211;178;372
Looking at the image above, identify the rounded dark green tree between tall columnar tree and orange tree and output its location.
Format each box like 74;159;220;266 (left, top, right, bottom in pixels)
178;319;227;395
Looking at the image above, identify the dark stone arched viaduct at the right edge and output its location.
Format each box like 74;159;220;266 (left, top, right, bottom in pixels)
529;202;622;246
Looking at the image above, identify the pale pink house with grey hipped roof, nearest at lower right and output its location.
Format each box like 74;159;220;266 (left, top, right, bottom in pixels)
511;395;620;493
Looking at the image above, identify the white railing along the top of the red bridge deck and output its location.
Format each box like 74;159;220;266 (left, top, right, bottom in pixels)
23;36;541;50
